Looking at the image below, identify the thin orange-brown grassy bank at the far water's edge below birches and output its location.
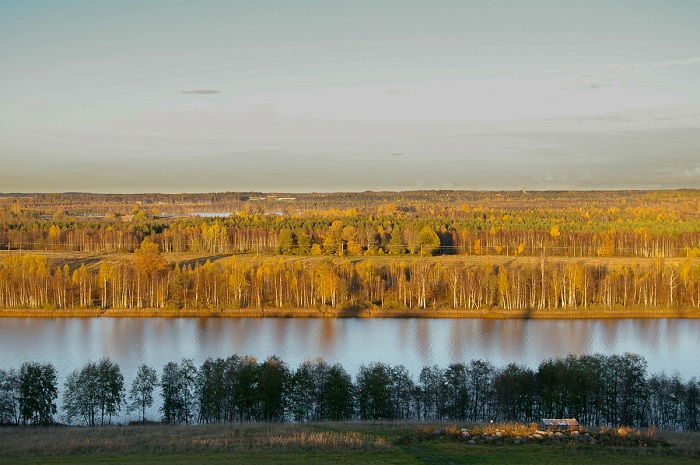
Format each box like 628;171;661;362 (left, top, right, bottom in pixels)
0;307;700;320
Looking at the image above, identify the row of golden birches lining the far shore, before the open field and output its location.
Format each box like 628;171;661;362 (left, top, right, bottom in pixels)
0;239;700;310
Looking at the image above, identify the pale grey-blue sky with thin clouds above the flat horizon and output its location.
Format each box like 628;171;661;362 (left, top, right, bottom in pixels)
0;0;700;193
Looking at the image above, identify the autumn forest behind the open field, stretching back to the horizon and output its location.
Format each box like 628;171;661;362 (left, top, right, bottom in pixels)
0;191;700;257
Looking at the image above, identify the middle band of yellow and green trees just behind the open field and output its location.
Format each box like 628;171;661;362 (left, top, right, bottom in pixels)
0;212;700;257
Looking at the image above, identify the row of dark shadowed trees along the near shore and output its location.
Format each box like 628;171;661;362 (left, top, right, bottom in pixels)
0;353;700;431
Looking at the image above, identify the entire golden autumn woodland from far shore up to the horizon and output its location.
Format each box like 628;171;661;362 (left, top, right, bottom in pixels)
0;190;700;310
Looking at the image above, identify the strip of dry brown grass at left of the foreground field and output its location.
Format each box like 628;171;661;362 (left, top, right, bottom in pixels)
0;424;389;457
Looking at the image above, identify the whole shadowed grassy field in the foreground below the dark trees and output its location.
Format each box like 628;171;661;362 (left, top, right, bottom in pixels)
0;423;700;465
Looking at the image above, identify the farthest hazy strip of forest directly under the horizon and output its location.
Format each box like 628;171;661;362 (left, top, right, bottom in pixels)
5;189;700;221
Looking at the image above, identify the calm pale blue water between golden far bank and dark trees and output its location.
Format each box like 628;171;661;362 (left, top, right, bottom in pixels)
0;318;700;384
